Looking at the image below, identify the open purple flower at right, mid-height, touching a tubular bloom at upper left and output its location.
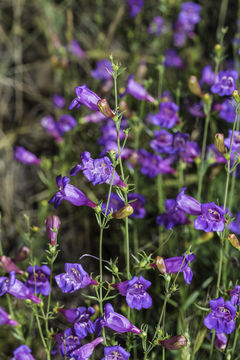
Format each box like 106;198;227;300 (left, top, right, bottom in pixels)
194;202;226;232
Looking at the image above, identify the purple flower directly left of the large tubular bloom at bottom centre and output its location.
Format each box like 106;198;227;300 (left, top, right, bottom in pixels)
58;306;95;339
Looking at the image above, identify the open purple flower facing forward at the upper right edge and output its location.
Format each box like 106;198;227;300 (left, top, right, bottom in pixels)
211;70;238;96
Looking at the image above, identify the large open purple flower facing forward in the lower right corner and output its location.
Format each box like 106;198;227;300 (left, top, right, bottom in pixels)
204;297;237;334
